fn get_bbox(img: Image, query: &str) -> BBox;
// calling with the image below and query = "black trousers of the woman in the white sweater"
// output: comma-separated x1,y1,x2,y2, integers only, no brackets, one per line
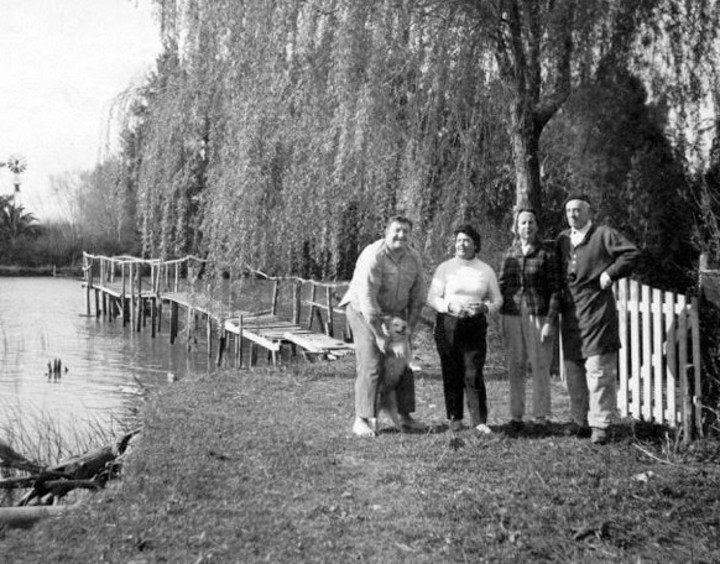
435,313,487,427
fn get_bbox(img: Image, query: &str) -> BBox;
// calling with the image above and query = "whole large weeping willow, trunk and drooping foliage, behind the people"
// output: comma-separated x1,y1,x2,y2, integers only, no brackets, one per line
135,0,717,277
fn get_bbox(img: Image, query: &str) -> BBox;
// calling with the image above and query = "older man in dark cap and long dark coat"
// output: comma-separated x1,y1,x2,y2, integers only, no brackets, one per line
557,194,639,444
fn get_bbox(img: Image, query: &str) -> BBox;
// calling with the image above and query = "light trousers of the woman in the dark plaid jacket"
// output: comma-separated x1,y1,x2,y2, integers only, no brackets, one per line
502,301,555,421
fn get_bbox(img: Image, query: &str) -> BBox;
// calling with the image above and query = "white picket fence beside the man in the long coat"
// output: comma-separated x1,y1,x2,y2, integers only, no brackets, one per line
560,278,702,438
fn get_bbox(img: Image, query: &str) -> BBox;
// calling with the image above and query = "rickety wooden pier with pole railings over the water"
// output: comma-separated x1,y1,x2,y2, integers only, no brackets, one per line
83,253,353,367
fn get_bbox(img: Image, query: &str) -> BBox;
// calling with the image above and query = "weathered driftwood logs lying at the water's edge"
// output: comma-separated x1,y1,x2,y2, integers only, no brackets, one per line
0,429,140,527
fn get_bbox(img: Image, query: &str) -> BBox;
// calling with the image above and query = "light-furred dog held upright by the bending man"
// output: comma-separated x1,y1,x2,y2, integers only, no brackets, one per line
378,316,411,430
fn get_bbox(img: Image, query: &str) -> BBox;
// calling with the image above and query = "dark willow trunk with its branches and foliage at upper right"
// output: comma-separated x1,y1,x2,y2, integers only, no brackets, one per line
444,0,720,209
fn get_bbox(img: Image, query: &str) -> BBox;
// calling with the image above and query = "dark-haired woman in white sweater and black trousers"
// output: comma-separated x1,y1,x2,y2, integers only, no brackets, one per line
428,225,502,434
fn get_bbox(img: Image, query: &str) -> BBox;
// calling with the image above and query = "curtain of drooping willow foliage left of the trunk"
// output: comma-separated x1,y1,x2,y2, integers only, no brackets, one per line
138,0,505,276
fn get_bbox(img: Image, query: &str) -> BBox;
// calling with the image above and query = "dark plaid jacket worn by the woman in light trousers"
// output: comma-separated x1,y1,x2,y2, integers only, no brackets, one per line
499,242,562,322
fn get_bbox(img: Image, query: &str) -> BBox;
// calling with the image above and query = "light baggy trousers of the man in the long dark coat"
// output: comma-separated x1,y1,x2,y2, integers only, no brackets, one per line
563,351,618,429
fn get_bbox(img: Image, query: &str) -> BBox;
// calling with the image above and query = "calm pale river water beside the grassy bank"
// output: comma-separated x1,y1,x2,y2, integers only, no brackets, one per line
0,277,213,454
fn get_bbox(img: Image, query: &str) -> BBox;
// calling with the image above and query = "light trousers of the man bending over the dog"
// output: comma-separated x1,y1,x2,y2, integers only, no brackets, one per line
345,305,415,419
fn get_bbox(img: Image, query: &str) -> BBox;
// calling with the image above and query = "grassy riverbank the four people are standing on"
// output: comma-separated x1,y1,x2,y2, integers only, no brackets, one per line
0,328,720,564
